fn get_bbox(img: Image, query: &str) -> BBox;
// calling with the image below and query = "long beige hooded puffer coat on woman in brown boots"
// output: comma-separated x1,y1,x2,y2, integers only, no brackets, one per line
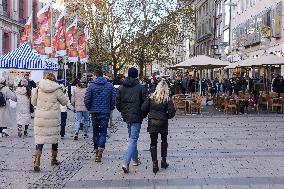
32,79,68,144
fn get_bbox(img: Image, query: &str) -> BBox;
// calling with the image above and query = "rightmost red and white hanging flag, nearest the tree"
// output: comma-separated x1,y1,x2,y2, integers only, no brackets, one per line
78,26,88,63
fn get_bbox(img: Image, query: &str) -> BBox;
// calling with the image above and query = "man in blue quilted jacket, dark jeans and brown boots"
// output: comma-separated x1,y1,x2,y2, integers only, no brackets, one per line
84,70,116,162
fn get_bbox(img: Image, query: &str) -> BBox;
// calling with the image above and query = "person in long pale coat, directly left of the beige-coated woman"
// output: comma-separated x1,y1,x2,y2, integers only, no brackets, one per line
16,80,31,137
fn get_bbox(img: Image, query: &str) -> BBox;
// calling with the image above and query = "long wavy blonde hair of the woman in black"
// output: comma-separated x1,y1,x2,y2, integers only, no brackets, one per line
150,81,169,104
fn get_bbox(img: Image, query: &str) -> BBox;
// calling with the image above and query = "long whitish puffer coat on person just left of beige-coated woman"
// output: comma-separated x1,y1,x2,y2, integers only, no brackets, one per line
16,87,31,126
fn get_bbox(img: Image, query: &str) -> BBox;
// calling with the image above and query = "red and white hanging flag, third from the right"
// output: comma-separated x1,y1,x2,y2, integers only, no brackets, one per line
52,8,67,56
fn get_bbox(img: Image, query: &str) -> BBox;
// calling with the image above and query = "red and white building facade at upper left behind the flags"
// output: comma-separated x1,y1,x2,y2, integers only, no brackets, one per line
0,0,43,55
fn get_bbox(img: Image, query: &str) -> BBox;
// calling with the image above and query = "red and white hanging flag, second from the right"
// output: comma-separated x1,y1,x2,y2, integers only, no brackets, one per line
66,15,78,62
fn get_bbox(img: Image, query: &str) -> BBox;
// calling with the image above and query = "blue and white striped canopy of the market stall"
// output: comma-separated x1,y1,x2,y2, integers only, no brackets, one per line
0,43,58,70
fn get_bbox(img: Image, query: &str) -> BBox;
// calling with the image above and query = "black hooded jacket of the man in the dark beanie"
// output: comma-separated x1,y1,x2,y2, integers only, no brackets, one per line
116,77,147,124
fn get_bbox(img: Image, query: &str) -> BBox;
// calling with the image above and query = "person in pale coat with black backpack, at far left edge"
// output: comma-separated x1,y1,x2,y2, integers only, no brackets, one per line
0,78,17,137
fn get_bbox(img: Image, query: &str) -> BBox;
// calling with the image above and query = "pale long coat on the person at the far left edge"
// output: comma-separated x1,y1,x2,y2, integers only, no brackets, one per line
0,84,17,128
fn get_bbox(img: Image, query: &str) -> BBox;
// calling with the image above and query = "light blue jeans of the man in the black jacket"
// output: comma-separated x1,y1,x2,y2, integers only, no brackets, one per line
124,123,141,165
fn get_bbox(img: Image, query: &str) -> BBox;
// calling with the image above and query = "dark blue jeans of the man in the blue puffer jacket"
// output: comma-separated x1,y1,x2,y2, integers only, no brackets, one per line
92,113,110,150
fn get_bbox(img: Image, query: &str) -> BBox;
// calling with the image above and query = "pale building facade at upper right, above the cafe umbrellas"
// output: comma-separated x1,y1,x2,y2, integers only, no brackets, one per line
231,0,284,77
